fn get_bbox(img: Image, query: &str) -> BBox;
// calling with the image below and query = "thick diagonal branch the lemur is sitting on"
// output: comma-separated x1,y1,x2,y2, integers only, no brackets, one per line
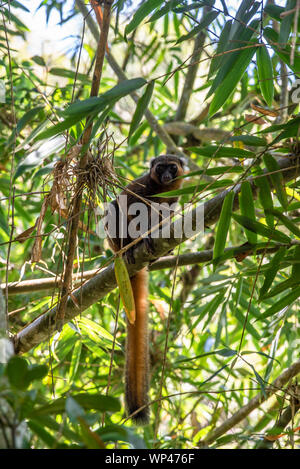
14,157,299,353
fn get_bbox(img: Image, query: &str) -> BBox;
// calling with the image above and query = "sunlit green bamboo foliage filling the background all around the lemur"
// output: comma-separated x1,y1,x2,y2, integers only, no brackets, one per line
0,0,300,449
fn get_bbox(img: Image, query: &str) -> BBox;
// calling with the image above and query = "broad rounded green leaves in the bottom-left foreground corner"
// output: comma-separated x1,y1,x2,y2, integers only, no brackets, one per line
0,357,137,449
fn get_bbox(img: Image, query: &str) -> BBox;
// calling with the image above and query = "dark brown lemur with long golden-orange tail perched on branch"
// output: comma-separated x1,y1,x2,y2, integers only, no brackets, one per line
109,155,184,425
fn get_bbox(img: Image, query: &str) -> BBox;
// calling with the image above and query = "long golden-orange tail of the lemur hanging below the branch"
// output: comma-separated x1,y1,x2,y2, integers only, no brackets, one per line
125,268,149,425
